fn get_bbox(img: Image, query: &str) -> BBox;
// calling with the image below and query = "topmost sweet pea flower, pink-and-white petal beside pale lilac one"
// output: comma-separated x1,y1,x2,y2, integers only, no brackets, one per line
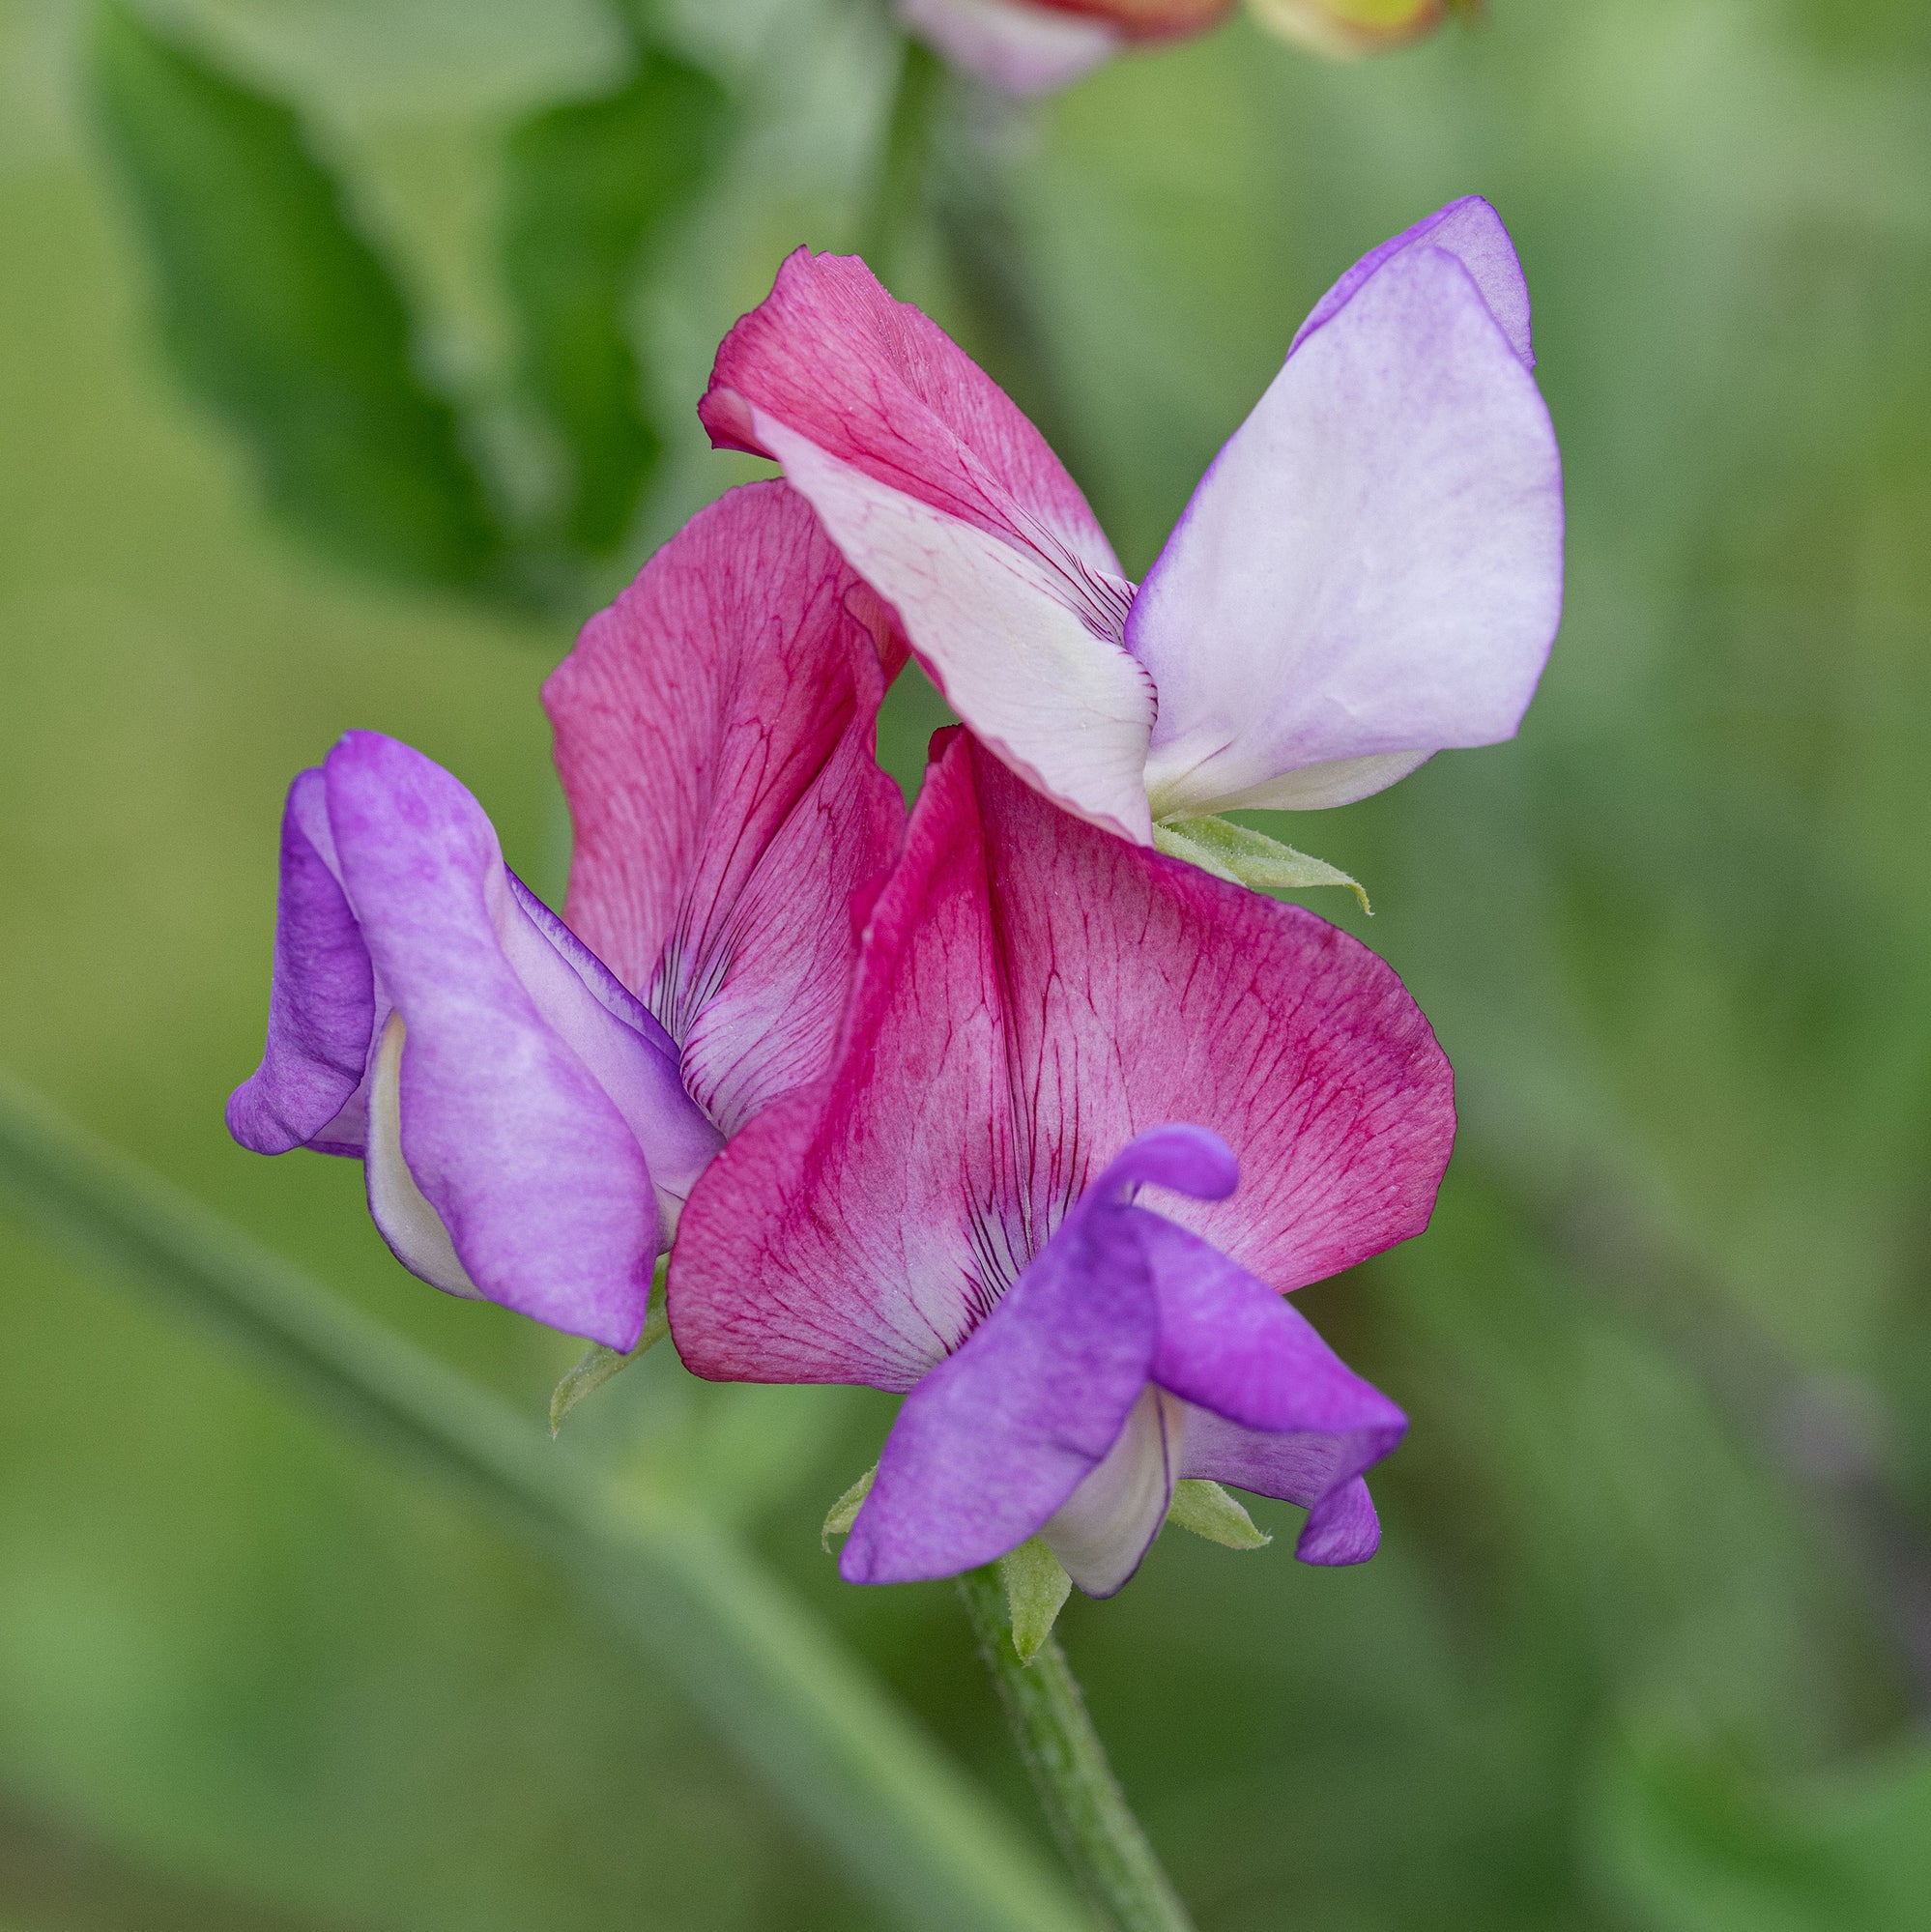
702,195,1562,845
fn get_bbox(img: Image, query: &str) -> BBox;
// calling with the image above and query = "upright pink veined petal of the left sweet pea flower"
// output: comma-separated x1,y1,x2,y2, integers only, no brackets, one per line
543,483,905,1128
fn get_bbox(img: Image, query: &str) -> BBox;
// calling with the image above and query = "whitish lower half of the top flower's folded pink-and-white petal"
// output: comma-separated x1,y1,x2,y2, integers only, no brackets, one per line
754,412,1154,845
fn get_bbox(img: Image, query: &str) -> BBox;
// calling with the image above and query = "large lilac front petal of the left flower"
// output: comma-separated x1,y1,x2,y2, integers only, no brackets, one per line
325,733,688,1348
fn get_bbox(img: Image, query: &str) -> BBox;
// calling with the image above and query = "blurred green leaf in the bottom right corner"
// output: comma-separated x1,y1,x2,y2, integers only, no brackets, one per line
1602,1743,1931,1932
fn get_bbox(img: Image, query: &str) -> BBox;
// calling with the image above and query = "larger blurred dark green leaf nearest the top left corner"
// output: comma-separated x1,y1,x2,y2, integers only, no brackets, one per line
93,6,503,586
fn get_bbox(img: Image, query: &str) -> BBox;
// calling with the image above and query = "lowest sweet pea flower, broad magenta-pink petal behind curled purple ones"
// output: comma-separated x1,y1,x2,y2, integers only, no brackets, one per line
667,729,1454,1596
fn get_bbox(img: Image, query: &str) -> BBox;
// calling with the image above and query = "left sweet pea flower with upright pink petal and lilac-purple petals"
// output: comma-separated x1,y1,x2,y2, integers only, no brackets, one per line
228,483,903,1350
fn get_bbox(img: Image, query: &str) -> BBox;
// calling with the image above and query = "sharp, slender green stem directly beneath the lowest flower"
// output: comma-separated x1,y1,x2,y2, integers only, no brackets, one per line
959,1565,1193,1932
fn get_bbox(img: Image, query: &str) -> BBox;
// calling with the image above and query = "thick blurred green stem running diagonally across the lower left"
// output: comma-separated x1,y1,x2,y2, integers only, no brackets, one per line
0,1074,1090,1932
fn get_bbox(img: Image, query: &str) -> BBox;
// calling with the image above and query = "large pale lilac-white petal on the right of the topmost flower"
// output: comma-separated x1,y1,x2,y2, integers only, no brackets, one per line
1127,240,1562,818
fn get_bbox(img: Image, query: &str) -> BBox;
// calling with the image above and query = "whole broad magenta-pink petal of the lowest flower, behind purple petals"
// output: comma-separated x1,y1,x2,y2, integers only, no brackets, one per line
671,733,1454,1389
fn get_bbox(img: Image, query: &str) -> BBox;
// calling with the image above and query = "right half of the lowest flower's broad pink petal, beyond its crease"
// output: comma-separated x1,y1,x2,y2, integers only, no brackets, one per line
974,735,1455,1290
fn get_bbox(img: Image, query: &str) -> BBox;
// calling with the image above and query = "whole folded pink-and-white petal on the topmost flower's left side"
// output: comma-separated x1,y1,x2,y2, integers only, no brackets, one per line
702,249,1154,841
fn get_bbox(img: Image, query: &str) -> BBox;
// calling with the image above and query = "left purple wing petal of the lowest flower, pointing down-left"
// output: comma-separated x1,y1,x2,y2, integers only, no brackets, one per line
839,1201,1158,1582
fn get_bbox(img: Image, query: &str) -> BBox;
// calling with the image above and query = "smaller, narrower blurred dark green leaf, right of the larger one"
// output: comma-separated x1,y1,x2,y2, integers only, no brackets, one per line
503,37,727,557
